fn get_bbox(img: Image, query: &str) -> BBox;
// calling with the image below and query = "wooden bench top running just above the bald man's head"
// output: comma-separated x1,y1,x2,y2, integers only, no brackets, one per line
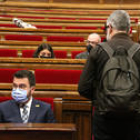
0,28,105,38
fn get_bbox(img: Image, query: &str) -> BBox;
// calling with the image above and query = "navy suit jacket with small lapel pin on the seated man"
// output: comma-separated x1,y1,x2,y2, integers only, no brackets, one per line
0,99,55,123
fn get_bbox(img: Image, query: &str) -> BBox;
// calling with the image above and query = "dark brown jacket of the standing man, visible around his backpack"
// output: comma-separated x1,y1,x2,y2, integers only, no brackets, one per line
78,33,140,100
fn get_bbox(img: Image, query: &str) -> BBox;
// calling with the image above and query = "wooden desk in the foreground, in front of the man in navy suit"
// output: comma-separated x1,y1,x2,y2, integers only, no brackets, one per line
0,123,76,140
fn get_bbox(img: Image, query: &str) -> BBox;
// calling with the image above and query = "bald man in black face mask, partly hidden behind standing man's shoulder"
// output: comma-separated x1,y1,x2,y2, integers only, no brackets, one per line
75,33,101,59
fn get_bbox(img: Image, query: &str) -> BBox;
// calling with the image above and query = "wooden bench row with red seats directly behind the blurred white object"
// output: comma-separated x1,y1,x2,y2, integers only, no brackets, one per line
0,15,139,29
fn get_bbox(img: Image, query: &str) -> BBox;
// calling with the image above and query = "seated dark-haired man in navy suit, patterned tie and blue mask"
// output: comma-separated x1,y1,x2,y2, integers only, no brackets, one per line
0,70,55,123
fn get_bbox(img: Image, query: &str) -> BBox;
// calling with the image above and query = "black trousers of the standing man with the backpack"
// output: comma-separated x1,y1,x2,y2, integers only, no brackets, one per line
92,111,140,140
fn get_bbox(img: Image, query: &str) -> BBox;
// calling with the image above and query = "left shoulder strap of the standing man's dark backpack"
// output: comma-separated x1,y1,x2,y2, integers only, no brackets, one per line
98,42,114,57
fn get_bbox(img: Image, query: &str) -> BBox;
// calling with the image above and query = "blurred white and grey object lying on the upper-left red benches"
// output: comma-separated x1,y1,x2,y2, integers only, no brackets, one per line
13,18,37,29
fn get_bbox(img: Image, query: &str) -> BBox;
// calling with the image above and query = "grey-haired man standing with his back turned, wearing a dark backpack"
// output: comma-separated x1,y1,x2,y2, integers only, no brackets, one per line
78,10,140,140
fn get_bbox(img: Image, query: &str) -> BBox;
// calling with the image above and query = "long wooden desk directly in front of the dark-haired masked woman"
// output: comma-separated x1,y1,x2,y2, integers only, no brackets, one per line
0,57,86,70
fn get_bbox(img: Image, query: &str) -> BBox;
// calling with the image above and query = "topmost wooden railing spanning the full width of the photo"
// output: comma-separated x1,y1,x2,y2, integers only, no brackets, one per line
0,0,140,10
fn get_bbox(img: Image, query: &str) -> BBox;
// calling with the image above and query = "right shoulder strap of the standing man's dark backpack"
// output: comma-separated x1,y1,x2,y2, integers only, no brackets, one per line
128,43,140,58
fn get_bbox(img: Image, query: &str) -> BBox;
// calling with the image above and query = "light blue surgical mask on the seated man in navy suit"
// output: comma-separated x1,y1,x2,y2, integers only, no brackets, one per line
12,88,28,103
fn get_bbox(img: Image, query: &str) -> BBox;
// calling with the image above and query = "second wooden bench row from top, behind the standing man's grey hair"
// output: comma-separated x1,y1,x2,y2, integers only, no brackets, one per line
0,8,140,19
